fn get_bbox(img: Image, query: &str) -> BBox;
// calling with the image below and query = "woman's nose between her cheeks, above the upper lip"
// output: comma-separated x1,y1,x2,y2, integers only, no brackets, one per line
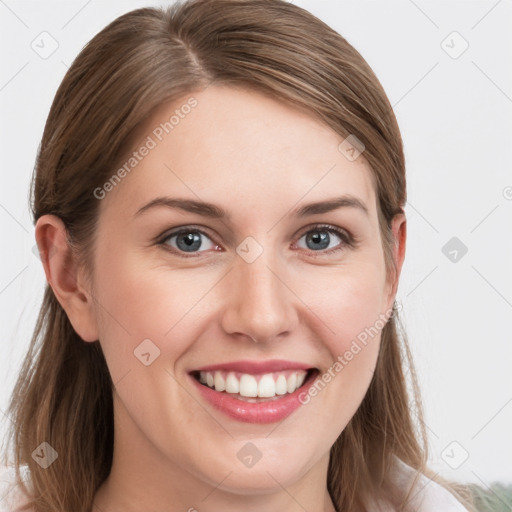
222,251,298,344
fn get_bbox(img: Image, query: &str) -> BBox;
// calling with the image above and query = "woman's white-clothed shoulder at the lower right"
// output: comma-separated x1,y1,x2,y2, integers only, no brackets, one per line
394,459,468,512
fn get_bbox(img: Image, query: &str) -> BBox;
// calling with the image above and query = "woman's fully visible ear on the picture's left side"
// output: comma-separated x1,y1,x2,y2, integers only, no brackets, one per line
35,215,98,341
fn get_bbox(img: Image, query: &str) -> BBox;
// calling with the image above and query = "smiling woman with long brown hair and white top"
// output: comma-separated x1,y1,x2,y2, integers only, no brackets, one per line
0,0,470,512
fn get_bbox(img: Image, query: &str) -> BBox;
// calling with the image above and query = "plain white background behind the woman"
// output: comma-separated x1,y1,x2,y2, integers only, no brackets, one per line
0,0,512,492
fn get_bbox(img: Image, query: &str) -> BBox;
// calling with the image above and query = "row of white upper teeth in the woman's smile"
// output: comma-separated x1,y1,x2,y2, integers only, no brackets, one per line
199,370,307,398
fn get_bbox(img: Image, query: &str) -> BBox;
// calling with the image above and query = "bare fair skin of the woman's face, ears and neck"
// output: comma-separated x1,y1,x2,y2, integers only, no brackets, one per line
36,85,406,512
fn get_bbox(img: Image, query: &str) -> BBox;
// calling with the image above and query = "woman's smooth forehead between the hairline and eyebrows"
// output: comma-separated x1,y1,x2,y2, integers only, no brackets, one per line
102,85,375,218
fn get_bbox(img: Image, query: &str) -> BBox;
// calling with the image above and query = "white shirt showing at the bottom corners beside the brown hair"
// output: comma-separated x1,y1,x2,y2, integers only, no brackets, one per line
0,461,468,512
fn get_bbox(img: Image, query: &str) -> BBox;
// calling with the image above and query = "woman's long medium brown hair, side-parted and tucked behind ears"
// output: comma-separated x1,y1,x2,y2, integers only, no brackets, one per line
4,0,474,512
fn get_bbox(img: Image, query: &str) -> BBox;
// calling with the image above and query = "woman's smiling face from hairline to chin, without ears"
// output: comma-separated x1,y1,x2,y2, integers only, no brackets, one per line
84,86,400,493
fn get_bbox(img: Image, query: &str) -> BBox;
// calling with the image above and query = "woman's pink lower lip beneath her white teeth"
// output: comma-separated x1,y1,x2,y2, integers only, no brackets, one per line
190,371,317,423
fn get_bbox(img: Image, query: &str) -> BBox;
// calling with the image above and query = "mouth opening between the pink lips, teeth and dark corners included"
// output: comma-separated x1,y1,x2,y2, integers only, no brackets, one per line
190,368,318,403
